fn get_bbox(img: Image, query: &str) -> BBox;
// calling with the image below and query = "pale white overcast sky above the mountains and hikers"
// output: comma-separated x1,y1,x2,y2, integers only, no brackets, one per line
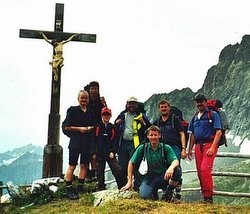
0,0,250,152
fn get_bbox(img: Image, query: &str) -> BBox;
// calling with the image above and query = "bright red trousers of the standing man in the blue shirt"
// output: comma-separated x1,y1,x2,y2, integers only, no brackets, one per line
195,143,218,198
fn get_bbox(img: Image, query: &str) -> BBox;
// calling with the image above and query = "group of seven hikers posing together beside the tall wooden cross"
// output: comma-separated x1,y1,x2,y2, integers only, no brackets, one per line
62,81,226,203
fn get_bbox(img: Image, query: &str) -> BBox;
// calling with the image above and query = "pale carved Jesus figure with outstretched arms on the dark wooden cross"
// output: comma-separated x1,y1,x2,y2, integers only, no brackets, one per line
41,32,75,81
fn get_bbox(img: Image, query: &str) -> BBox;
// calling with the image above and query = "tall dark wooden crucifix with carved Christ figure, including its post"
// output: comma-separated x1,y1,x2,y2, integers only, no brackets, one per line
19,3,96,178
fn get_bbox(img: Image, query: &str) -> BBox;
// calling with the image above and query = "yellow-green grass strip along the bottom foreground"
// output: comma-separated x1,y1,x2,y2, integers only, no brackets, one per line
0,195,250,214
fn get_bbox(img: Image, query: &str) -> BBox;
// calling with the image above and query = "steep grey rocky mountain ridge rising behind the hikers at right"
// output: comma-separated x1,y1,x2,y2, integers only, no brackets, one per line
144,35,250,152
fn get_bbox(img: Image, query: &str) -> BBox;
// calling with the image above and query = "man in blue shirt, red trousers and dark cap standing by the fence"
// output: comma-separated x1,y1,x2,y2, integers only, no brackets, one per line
188,93,221,204
